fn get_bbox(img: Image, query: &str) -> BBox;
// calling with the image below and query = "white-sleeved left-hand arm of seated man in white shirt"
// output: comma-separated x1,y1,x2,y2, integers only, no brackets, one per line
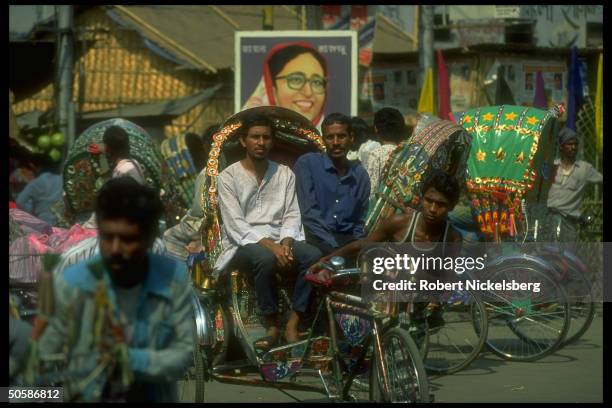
217,173,266,246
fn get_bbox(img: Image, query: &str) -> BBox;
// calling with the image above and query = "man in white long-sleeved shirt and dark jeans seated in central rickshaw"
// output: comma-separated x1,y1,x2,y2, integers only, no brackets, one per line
215,115,322,349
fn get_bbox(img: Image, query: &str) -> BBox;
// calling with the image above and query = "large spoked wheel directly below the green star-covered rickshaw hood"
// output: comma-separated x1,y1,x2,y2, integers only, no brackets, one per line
483,263,570,361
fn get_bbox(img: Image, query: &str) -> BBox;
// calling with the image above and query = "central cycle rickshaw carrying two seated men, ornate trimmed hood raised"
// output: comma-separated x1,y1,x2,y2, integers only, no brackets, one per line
186,107,430,402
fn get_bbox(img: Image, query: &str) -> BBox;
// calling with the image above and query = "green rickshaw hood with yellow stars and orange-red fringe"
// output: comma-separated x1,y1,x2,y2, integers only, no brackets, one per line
456,105,559,239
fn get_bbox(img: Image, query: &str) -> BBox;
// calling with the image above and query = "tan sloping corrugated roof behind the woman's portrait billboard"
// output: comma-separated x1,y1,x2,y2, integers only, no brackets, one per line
27,5,416,73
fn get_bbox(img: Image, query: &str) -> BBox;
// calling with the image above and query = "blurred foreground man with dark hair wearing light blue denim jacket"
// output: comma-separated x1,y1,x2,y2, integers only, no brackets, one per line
39,177,195,402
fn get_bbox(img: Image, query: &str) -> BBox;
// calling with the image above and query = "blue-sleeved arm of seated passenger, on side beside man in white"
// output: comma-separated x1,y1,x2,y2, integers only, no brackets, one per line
293,159,338,247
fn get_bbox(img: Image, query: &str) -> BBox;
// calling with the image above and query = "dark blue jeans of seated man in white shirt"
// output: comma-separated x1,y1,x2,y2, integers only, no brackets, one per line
232,241,323,316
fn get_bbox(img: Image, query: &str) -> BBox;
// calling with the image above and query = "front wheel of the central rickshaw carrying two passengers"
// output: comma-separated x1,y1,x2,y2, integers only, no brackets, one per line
370,327,429,402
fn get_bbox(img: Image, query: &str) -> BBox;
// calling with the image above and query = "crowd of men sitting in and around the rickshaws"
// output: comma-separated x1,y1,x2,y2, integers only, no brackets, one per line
10,102,602,401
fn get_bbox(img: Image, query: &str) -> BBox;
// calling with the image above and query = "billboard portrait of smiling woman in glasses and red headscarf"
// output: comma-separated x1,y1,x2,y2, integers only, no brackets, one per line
234,31,358,128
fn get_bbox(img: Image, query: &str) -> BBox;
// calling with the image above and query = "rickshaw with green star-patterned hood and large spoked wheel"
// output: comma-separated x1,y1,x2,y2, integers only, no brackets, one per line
455,105,570,361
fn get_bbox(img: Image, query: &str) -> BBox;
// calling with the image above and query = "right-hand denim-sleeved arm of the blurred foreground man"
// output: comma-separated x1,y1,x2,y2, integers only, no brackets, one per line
128,263,195,381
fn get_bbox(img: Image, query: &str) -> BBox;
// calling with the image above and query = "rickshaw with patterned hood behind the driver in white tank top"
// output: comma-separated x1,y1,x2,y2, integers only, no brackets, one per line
366,115,487,375
